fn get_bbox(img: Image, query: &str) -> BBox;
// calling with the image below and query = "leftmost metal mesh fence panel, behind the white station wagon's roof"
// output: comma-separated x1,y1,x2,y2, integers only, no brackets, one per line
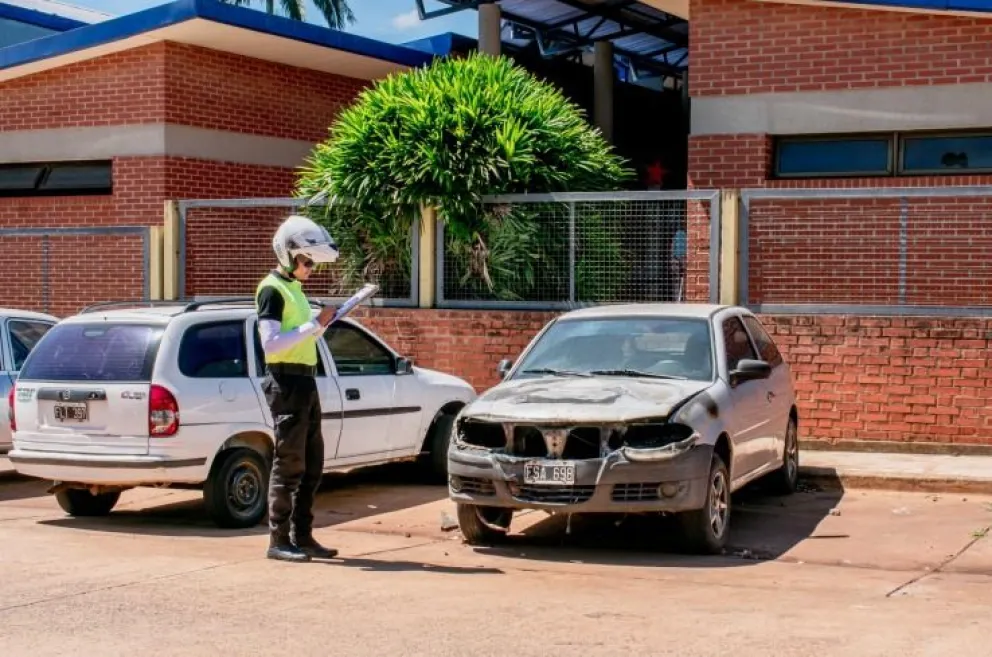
0,226,151,316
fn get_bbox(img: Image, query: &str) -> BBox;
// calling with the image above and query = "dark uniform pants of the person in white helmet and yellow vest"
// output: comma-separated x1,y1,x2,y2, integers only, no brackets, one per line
262,372,324,542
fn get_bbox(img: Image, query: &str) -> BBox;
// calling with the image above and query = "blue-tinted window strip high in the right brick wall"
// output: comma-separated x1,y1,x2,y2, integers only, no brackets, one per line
772,132,992,178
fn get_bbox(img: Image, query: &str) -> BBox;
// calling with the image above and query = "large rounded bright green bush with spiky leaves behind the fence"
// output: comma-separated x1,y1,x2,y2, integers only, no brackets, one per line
297,54,631,299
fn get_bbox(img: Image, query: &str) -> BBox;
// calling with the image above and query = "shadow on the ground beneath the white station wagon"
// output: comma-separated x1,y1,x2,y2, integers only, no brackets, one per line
35,463,448,538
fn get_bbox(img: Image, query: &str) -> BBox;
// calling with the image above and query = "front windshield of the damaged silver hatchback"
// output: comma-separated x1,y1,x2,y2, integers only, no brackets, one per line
514,317,713,381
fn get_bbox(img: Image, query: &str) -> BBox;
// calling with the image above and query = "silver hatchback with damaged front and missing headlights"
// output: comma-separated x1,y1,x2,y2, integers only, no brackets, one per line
448,304,799,553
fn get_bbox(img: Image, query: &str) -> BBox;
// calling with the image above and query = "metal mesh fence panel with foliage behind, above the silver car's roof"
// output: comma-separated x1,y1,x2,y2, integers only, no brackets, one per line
436,190,720,309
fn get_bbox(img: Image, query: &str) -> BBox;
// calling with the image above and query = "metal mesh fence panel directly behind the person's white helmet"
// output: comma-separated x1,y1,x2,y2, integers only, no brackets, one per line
177,198,420,306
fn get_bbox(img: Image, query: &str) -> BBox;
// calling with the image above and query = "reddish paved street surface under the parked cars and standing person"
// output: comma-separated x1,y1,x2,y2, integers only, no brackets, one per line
0,467,992,657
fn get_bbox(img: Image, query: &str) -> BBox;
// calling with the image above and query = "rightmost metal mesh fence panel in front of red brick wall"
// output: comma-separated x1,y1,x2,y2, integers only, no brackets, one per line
738,186,992,315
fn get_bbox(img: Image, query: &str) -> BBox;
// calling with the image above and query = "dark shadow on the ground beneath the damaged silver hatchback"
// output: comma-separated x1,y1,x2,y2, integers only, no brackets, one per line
476,477,846,568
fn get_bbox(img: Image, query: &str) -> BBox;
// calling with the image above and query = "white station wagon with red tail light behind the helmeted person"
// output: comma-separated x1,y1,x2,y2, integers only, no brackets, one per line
10,300,475,527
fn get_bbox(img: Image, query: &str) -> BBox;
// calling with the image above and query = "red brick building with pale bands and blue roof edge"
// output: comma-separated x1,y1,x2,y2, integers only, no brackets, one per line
0,0,992,445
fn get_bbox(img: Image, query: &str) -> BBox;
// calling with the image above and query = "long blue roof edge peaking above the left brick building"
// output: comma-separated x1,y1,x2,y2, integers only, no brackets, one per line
0,0,433,69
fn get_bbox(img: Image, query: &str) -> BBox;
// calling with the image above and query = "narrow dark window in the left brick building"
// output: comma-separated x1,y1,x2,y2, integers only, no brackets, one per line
0,161,113,196
